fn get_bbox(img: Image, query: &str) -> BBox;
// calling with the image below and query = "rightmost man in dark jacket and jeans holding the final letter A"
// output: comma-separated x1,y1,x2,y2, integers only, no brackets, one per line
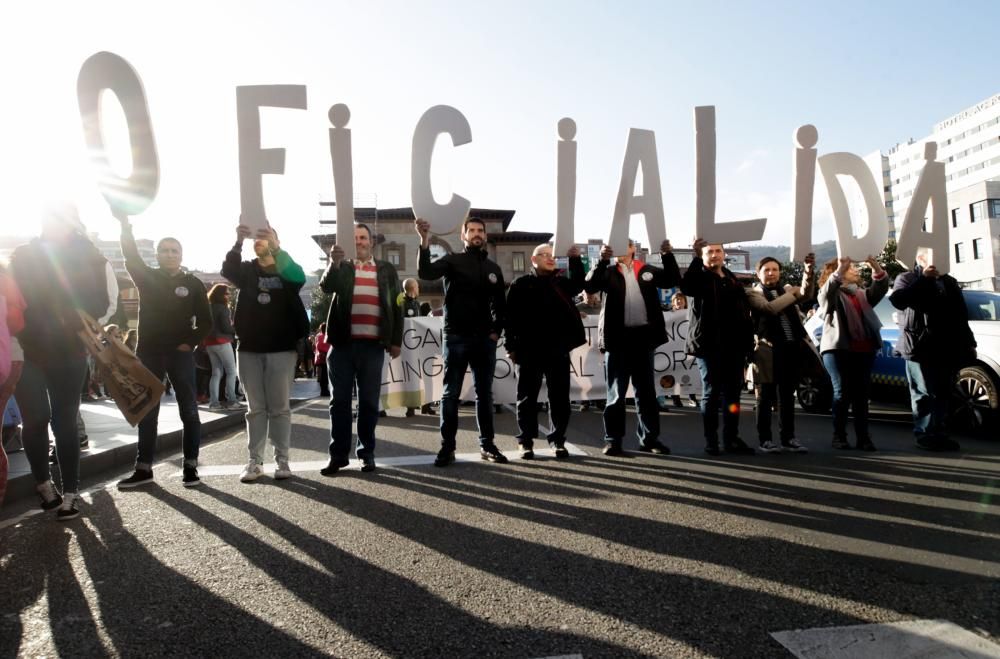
889,249,976,451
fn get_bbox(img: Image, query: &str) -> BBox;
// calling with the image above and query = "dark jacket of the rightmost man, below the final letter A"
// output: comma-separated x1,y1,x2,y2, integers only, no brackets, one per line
889,266,976,365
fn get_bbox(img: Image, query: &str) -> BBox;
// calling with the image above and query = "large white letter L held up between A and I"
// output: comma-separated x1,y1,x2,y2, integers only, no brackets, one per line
694,105,767,244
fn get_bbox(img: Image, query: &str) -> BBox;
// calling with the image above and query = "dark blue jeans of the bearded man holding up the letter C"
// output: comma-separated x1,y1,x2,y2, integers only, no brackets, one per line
441,335,497,451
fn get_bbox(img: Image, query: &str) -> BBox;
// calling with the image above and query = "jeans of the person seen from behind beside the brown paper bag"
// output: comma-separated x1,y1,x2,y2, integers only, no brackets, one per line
14,355,87,492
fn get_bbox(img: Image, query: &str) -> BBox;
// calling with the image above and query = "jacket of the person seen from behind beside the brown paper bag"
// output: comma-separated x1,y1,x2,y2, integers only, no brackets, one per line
10,235,110,364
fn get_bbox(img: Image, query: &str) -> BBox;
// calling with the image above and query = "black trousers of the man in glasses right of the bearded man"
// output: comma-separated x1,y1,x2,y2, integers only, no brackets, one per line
517,352,570,448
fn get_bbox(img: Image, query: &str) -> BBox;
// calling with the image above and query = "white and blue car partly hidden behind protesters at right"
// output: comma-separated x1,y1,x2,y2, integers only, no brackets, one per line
797,290,1000,431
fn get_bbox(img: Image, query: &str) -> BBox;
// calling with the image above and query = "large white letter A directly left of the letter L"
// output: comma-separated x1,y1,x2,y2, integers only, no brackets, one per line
608,128,667,254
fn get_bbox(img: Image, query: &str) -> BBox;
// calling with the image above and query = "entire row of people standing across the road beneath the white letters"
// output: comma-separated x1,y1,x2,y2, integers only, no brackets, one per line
0,207,975,520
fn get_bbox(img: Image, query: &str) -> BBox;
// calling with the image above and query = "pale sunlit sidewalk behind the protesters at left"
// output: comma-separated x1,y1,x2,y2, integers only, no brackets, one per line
4,379,319,505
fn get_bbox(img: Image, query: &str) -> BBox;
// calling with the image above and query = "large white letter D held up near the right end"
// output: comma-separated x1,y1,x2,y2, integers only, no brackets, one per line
819,152,889,260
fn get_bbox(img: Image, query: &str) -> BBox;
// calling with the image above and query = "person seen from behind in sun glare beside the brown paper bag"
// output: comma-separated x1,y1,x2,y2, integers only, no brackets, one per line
10,206,118,520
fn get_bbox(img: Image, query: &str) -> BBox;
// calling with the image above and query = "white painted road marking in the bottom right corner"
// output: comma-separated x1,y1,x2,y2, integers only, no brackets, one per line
771,620,1000,659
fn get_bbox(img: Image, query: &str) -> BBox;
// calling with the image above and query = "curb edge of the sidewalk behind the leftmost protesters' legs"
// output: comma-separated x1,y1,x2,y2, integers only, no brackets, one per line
4,398,313,508
